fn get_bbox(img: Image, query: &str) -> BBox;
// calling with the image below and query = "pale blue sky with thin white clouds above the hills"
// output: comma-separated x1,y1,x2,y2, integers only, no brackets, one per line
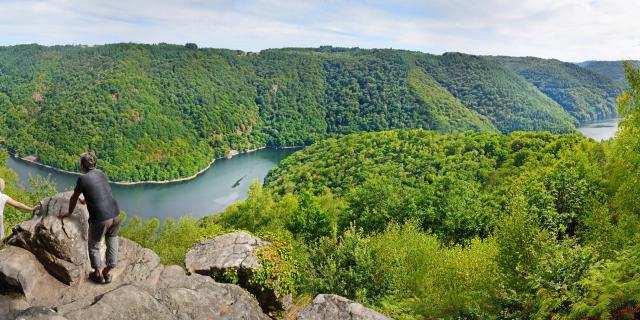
0,0,640,62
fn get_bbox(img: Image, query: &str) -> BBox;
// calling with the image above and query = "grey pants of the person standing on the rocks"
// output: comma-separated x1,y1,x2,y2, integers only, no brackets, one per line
89,216,120,269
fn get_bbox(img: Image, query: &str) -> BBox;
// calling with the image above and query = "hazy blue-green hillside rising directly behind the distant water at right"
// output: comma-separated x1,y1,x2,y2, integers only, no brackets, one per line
493,57,622,122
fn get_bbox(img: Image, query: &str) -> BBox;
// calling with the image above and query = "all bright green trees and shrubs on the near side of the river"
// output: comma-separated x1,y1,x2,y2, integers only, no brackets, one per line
0,65,640,319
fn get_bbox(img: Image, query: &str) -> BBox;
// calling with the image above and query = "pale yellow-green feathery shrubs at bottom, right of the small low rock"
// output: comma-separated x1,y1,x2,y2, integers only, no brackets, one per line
372,223,497,319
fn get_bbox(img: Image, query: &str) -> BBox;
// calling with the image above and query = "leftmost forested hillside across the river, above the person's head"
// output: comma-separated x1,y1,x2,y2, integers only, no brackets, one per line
0,44,264,181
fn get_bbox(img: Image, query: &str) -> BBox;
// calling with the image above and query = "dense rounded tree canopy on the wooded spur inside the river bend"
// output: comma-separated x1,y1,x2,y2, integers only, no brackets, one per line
265,130,604,243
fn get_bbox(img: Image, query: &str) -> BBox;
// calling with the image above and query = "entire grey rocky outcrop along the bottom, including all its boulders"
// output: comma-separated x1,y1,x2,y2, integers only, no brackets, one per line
0,193,396,320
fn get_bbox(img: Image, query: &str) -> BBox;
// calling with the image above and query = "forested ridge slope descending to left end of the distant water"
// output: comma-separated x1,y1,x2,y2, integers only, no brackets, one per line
415,53,576,133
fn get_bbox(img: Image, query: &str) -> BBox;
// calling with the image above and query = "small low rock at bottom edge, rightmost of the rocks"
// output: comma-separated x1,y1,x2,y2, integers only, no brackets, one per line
298,294,391,320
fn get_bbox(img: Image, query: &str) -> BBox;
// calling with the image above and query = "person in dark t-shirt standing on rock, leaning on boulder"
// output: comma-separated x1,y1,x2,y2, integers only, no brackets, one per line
60,152,120,284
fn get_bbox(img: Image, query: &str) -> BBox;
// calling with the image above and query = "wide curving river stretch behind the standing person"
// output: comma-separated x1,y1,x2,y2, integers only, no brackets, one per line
8,149,297,220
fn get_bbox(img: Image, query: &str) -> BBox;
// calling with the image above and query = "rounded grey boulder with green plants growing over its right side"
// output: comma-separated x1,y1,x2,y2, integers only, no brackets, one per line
185,232,292,315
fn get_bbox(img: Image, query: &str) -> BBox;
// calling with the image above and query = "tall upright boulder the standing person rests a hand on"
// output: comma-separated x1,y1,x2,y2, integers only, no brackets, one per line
8,192,90,285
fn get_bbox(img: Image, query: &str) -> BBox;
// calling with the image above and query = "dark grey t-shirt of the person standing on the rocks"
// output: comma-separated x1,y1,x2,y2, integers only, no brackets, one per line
75,169,120,223
